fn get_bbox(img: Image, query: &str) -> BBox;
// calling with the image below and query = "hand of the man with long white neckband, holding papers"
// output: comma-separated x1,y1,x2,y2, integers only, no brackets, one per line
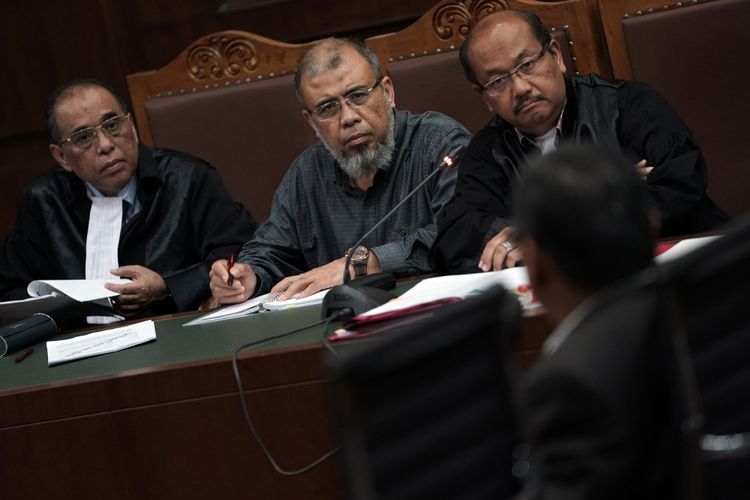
104,266,169,314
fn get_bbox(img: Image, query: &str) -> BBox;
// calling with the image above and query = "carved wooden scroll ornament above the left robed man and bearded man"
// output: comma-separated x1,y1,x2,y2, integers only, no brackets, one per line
186,36,258,81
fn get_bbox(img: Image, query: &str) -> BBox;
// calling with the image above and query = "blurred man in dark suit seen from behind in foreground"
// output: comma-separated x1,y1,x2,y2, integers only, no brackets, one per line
513,147,680,500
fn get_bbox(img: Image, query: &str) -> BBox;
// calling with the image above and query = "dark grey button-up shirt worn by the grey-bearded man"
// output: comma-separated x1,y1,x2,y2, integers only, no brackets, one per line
238,111,470,293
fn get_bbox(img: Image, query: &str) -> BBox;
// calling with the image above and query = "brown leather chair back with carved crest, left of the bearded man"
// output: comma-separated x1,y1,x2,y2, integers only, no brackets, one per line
128,31,315,221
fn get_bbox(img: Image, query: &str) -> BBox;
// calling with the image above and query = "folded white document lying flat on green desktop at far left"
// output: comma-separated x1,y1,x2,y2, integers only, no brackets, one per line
47,320,156,366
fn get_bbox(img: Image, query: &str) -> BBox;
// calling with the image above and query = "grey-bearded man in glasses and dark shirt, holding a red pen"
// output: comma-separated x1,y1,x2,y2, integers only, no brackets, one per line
210,38,470,304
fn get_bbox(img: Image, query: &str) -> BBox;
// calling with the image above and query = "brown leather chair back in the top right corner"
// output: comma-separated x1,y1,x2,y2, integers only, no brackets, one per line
600,0,750,217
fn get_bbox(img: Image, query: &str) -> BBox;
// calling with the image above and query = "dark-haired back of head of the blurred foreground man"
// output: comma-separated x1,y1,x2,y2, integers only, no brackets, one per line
514,146,653,290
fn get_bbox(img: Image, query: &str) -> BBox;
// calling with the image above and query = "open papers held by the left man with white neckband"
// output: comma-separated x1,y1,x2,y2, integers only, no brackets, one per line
0,278,130,320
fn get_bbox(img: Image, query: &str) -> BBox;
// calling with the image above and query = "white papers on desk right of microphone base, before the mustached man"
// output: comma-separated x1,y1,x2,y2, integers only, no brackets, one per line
355,267,541,319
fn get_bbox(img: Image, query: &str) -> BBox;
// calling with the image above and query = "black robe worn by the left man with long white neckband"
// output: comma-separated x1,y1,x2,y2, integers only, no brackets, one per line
0,146,257,316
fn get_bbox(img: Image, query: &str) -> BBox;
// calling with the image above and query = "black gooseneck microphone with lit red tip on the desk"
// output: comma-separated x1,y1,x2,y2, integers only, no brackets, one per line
321,146,464,318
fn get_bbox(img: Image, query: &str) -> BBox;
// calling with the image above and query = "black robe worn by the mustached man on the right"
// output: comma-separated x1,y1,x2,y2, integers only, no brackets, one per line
431,75,728,273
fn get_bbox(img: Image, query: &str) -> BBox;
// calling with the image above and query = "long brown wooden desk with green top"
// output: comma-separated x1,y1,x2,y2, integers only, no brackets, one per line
0,294,549,500
